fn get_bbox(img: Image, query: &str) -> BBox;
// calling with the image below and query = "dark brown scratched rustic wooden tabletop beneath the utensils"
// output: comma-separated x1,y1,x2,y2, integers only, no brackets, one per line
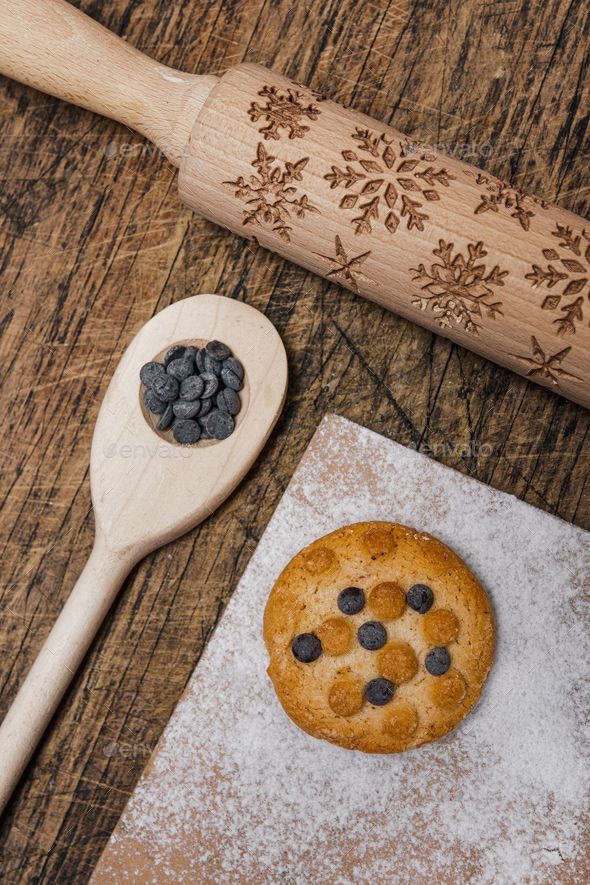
0,0,590,883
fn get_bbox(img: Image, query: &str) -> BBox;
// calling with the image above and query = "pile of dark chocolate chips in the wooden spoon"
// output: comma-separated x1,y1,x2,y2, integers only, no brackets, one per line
139,341,244,445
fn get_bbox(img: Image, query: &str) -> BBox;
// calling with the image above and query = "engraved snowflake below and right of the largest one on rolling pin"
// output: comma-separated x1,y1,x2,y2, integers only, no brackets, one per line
410,240,508,335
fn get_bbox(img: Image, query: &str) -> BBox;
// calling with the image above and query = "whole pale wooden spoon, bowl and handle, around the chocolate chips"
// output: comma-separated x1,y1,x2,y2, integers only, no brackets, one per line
0,295,287,811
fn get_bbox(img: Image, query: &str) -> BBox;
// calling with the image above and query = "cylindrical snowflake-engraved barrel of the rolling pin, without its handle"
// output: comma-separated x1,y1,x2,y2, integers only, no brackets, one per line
178,63,590,408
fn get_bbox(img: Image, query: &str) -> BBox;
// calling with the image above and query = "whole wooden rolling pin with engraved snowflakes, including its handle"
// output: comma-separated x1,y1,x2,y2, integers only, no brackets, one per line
0,0,590,407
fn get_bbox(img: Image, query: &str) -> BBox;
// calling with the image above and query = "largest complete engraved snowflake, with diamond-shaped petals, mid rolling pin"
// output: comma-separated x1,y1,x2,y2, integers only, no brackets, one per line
324,127,455,234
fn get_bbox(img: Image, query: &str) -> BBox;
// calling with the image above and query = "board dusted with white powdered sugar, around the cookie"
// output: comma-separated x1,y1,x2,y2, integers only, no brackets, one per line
95,417,590,883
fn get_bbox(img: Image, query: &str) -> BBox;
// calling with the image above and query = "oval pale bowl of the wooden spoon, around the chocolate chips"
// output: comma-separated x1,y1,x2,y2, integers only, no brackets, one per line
90,295,287,559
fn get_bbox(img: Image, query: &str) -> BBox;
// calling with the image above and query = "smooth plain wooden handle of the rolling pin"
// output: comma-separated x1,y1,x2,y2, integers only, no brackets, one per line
0,0,217,165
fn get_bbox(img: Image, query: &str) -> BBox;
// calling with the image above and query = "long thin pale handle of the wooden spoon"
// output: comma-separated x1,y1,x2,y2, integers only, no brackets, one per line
0,542,133,812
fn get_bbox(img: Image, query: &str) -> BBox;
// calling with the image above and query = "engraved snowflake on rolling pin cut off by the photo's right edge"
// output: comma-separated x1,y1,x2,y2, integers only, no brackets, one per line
526,224,590,335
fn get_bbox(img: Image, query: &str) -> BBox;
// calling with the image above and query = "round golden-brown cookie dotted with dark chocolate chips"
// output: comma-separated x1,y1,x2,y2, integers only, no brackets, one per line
264,522,495,753
